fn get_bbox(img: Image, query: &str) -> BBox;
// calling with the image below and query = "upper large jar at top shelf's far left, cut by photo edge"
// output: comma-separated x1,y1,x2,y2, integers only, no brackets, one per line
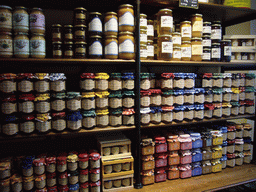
0,5,13,32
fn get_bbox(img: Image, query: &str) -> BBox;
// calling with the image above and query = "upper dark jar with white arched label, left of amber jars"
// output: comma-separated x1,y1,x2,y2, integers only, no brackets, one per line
88,12,102,36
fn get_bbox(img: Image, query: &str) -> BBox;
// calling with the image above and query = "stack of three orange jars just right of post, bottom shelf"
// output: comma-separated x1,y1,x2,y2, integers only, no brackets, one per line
141,138,155,185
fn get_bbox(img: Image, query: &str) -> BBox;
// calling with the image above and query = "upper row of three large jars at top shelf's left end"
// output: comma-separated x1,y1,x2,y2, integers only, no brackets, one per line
0,5,45,34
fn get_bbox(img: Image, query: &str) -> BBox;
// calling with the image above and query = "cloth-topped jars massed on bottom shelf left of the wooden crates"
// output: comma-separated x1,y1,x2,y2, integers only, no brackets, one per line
0,150,101,192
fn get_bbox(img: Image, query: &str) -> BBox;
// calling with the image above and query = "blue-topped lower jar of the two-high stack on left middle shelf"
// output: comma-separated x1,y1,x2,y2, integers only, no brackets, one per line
67,111,83,131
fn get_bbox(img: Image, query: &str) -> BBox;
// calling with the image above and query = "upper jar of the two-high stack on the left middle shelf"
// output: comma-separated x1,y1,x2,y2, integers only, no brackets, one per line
66,92,82,112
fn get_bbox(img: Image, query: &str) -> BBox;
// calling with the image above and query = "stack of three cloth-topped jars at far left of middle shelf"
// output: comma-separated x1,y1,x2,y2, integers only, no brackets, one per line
0,73,19,136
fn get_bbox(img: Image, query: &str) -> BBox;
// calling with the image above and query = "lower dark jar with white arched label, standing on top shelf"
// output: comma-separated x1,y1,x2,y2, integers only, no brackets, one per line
88,35,103,59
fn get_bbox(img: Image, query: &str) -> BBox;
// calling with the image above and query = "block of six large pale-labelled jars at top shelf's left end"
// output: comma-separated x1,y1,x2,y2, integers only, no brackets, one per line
0,5,45,59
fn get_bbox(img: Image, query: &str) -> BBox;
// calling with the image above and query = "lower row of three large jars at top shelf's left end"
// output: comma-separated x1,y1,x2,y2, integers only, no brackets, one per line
0,32,46,59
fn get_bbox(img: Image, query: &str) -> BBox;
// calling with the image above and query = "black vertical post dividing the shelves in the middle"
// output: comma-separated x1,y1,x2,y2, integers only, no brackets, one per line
134,0,143,189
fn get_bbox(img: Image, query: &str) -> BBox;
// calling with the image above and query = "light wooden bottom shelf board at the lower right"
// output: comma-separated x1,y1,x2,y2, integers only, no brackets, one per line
129,164,256,192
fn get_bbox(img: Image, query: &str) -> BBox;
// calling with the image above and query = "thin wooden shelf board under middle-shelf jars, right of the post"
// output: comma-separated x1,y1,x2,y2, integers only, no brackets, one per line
141,115,254,128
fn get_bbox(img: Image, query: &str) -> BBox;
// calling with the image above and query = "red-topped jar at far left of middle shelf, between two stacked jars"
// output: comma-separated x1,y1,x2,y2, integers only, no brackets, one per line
1,95,18,115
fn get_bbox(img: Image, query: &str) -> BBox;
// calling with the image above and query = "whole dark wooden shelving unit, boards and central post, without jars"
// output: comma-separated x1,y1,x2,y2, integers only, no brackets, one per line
0,0,256,191
